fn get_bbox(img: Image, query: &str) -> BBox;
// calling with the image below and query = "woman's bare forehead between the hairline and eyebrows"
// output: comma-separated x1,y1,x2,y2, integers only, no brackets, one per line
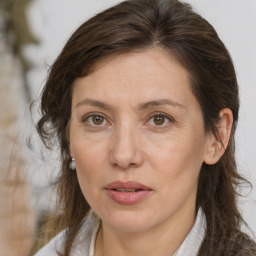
73,48,195,107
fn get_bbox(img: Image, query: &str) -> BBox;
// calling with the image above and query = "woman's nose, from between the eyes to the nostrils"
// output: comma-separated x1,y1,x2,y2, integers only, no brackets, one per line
110,124,144,170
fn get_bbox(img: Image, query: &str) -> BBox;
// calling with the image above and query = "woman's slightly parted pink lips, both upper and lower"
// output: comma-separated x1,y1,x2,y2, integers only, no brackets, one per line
105,181,153,205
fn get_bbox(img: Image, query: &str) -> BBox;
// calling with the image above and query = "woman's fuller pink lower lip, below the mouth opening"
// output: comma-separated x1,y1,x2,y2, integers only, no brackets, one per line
107,189,152,205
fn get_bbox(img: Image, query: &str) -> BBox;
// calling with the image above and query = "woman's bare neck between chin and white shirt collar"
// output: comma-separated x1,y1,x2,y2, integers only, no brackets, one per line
96,206,195,256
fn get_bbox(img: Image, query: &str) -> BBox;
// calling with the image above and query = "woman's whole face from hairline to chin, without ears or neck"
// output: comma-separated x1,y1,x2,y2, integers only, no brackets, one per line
70,48,213,232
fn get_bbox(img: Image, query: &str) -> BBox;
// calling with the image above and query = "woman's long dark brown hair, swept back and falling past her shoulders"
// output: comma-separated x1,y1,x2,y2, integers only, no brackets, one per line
37,0,256,255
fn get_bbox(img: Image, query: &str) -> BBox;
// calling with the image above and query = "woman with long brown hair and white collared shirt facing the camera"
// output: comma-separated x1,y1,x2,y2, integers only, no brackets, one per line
34,0,256,256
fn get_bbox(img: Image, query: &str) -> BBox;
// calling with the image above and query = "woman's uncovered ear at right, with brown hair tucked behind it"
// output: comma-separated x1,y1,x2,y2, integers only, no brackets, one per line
204,108,233,165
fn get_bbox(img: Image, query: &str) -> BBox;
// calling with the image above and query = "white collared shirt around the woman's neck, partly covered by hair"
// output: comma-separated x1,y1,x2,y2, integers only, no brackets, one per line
35,209,206,256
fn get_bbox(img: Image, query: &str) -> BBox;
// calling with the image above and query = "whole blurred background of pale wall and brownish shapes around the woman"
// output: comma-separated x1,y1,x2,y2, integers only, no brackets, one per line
0,0,256,256
